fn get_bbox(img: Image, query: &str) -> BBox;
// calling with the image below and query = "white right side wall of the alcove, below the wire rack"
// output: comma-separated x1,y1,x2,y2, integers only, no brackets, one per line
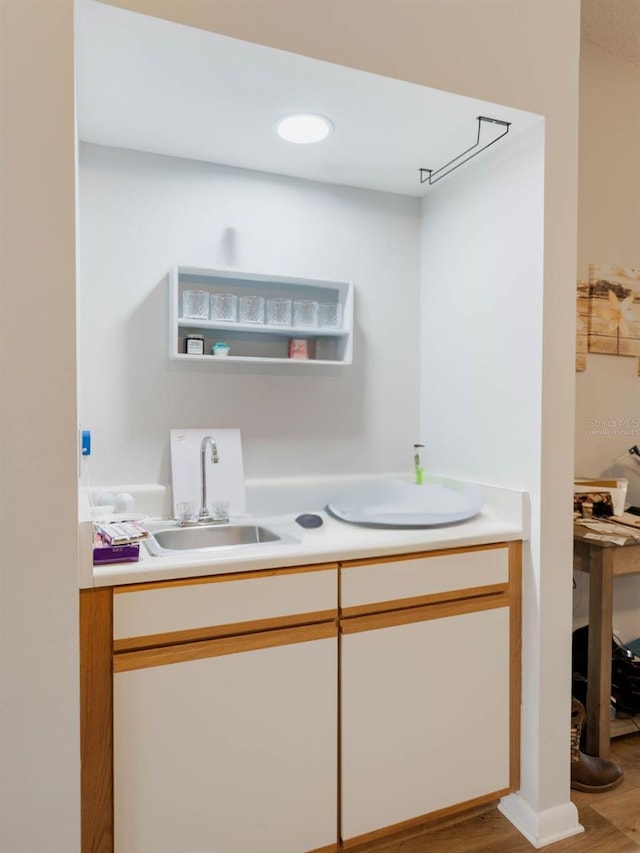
421,120,544,493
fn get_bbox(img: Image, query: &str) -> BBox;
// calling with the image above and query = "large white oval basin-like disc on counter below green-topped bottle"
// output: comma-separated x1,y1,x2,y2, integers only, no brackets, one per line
327,477,484,528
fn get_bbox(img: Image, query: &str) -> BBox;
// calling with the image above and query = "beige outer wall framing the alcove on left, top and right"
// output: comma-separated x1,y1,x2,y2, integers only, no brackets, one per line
0,0,579,853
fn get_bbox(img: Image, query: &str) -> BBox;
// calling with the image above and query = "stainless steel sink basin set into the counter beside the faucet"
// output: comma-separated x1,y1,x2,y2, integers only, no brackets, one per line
144,524,287,557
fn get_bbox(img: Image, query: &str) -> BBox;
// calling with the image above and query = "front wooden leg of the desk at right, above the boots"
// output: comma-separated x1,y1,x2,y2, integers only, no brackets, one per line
585,548,613,758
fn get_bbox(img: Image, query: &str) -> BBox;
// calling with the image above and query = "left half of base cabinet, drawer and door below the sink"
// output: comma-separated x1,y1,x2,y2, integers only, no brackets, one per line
112,564,338,853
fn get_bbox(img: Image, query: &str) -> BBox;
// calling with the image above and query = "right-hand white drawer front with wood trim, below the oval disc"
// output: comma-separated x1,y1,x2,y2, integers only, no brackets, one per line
340,544,509,615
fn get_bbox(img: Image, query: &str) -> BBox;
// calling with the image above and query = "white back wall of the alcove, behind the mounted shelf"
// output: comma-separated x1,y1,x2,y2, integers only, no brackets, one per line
80,145,419,485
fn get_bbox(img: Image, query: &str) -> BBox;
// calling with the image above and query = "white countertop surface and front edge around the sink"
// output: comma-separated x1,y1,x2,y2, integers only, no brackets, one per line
93,508,523,586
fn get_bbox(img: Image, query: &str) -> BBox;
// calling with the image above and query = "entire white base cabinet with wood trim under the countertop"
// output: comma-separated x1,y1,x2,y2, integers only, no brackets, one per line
81,542,521,853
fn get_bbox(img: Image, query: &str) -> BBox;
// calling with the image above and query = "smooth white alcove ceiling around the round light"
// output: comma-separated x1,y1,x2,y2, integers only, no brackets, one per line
76,0,541,196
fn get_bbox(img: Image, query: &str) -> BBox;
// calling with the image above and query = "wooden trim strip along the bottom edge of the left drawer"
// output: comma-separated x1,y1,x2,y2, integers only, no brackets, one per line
113,610,338,654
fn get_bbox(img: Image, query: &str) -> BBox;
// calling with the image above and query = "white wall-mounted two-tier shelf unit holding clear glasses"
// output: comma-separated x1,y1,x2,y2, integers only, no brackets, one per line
169,266,353,365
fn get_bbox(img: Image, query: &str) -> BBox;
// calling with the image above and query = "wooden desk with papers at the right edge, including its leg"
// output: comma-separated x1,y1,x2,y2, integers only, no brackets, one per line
573,525,640,758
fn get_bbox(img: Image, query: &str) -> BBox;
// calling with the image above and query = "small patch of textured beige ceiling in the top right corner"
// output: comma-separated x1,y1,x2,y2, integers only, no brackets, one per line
581,0,640,65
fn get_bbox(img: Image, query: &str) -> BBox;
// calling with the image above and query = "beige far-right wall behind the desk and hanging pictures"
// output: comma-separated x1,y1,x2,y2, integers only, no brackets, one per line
574,42,640,640
